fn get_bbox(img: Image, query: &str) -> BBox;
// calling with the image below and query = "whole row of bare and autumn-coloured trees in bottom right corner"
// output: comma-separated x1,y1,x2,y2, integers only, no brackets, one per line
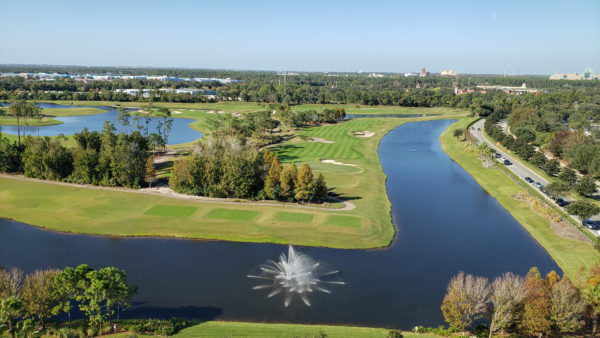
441,265,600,337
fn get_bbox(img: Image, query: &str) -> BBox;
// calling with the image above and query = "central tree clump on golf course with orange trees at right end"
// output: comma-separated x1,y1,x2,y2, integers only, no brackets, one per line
169,135,327,203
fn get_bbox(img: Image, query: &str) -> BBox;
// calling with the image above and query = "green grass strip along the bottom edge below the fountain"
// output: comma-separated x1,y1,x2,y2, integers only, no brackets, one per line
174,321,436,338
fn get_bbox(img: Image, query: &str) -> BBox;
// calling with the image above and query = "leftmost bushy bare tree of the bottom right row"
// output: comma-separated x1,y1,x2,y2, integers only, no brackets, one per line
442,271,490,331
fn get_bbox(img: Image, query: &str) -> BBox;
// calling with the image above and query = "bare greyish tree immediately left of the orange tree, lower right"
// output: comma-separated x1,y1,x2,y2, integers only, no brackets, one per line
489,272,527,337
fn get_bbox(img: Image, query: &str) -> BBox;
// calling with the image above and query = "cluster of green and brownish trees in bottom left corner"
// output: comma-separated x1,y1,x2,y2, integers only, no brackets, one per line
0,264,137,337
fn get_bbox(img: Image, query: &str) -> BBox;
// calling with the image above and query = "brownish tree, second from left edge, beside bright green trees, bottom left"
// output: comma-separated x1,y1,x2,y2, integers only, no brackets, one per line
21,269,58,326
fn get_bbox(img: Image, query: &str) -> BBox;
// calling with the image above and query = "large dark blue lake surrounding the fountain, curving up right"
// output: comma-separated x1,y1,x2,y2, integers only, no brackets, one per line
0,120,560,329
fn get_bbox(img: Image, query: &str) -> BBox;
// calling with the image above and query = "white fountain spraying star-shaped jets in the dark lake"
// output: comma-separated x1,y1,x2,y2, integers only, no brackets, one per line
248,245,345,307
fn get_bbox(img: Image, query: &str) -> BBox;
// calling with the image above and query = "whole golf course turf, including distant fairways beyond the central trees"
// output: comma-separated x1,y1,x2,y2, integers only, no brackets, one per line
0,103,466,249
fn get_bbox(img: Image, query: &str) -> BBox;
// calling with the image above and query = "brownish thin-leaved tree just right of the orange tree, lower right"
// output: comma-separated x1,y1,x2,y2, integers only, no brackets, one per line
550,277,586,333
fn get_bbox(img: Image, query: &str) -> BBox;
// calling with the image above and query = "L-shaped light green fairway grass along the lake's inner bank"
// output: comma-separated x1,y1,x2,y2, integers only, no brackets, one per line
0,108,468,249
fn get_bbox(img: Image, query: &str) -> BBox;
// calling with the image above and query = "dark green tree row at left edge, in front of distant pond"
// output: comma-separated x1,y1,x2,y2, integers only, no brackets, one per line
0,121,150,187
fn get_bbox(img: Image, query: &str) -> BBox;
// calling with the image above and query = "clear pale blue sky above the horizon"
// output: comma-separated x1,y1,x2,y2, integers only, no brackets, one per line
0,0,600,74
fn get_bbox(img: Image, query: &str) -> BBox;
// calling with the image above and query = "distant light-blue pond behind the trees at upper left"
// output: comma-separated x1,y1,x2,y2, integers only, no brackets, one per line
2,103,203,144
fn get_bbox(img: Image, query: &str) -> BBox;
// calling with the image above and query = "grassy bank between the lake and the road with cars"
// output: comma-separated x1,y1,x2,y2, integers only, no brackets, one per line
440,120,600,279
